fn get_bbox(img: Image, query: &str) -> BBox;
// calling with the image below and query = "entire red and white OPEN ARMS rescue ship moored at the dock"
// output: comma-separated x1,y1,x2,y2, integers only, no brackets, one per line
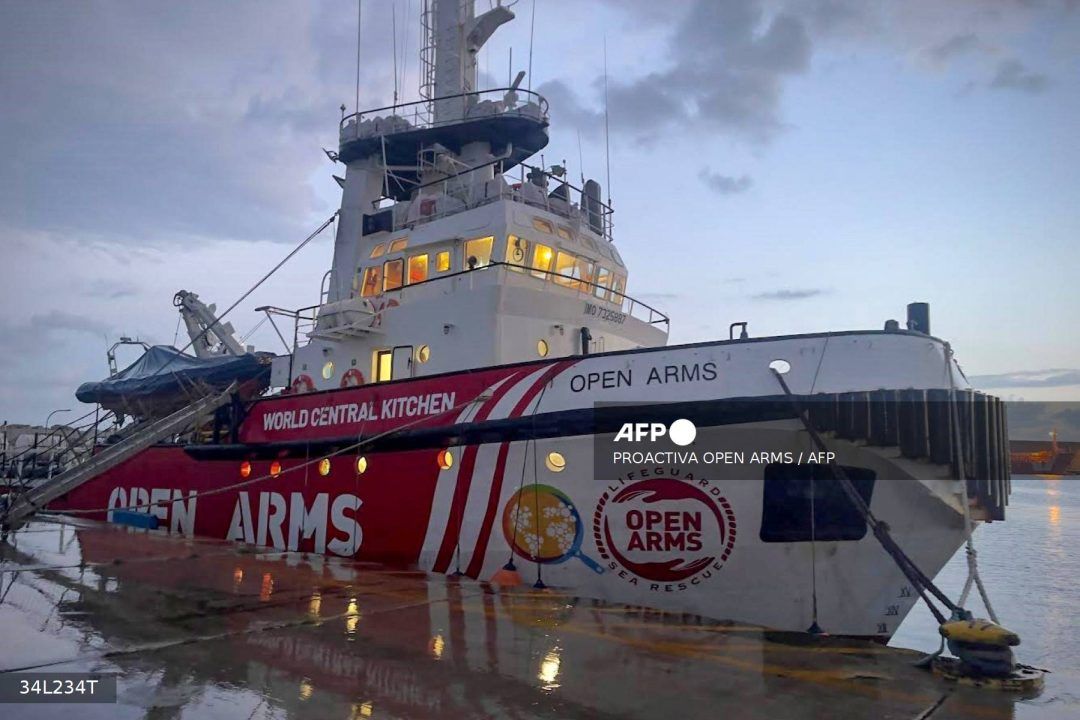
5,0,1009,640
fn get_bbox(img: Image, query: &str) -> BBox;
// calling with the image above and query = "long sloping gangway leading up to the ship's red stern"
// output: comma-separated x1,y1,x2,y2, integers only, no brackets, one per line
0,382,237,530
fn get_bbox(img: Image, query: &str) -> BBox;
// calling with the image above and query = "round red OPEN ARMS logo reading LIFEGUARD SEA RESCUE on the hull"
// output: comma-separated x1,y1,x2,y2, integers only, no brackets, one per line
593,477,735,592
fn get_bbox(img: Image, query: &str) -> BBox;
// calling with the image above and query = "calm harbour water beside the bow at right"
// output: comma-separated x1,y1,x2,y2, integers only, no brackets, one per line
891,475,1080,718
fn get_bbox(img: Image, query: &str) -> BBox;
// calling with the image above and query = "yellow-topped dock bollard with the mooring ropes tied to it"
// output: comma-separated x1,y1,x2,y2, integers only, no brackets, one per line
772,368,1042,690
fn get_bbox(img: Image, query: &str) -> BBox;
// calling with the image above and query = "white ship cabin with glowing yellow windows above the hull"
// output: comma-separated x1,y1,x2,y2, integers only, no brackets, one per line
272,168,669,392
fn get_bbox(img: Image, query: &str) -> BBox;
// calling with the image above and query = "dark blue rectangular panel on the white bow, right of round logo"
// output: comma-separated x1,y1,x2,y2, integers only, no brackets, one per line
760,463,877,543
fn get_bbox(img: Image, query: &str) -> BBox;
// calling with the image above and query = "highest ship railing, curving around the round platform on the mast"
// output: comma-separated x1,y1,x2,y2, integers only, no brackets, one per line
340,87,548,141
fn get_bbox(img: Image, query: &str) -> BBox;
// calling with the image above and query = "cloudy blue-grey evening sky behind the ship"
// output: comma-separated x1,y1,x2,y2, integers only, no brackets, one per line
0,0,1080,422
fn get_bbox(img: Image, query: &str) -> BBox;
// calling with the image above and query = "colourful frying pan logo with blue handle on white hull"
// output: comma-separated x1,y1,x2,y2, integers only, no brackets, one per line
502,485,604,574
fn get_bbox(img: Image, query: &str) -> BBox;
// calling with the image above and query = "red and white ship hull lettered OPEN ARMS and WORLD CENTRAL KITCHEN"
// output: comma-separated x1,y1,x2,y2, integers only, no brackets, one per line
52,334,980,639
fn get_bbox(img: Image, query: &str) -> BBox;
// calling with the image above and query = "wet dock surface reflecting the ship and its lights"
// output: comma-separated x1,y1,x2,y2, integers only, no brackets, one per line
0,520,1053,720
